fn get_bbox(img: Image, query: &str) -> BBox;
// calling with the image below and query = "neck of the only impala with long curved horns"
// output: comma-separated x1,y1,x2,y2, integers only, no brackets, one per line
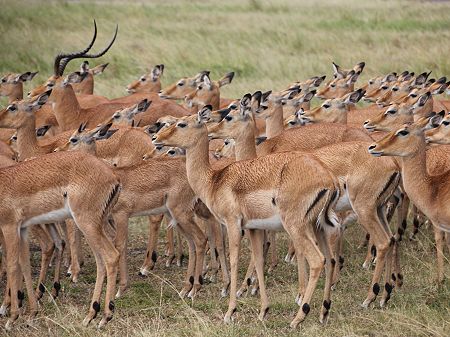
52,84,81,131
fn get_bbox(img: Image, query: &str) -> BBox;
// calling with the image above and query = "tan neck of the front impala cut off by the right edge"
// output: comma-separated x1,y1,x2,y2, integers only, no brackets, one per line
400,136,432,210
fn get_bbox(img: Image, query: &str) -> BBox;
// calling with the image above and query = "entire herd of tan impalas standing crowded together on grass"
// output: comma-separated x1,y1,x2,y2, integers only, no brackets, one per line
0,21,450,329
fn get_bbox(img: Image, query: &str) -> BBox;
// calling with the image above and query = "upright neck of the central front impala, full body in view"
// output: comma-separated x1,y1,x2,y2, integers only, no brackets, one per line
186,125,213,203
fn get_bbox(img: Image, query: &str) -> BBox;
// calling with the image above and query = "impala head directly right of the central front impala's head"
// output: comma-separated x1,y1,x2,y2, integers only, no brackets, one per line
208,91,262,139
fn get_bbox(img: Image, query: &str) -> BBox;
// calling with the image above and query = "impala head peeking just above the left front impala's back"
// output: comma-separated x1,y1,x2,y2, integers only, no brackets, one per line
53,123,117,154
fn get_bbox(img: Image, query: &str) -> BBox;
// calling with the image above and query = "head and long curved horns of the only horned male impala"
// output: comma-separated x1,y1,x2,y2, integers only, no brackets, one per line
28,20,119,97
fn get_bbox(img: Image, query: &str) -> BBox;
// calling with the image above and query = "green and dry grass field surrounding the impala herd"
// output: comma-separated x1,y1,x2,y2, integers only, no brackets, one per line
0,0,450,337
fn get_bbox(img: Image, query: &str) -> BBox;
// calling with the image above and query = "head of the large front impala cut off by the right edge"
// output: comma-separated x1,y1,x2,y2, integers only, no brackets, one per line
369,112,439,157
